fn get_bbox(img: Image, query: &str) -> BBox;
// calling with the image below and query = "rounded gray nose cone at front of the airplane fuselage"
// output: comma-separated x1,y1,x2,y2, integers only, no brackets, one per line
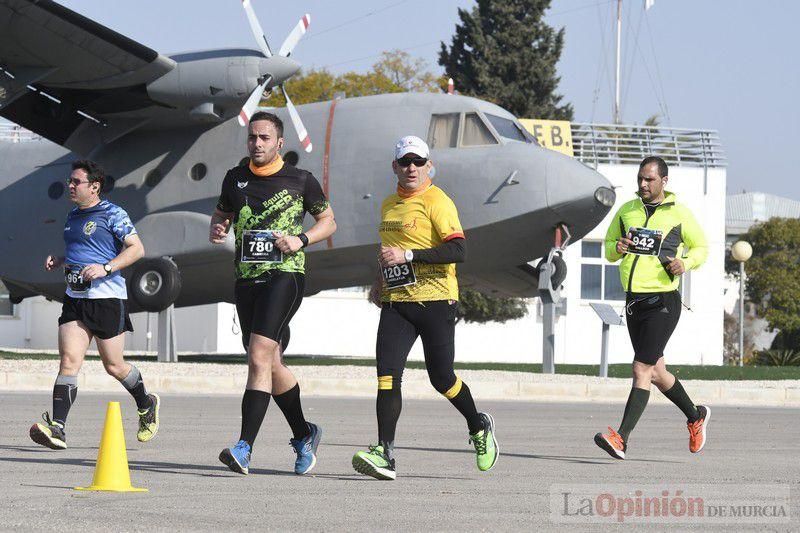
546,152,616,237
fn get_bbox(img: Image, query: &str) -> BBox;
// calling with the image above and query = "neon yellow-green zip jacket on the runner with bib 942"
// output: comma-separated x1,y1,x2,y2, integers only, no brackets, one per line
605,191,708,293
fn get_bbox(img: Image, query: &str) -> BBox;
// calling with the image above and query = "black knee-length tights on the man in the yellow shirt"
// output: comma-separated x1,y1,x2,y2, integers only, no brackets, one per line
376,300,458,394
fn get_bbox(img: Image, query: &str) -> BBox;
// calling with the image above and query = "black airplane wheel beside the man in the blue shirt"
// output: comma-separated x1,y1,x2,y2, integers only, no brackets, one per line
130,257,181,313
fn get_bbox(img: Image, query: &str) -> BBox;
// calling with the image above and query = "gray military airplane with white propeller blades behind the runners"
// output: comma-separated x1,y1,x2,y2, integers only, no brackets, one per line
0,0,614,311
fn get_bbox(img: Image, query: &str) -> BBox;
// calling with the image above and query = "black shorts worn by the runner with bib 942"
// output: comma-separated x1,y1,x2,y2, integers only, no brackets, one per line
625,291,681,365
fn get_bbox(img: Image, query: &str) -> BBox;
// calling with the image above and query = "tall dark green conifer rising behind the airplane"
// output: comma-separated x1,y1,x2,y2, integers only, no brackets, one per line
439,0,572,120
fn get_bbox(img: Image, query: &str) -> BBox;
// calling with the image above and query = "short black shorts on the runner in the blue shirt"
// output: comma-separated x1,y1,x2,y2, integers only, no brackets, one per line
58,294,133,339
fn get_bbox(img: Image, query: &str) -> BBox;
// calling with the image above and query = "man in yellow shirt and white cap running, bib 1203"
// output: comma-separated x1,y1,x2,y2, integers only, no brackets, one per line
353,136,499,479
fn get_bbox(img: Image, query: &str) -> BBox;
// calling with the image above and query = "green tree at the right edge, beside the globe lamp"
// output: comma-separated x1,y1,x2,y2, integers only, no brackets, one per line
729,218,800,349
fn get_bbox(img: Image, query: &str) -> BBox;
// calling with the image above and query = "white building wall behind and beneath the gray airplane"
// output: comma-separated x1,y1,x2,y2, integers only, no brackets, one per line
0,166,725,364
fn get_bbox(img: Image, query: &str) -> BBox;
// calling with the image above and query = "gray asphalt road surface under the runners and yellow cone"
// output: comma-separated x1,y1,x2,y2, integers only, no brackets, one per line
0,393,800,531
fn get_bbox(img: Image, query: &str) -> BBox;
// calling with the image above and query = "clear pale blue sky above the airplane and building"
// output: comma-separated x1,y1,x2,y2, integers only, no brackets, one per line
61,0,800,200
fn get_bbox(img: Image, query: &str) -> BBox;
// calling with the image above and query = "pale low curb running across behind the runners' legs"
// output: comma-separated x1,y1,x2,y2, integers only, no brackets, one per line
0,371,800,407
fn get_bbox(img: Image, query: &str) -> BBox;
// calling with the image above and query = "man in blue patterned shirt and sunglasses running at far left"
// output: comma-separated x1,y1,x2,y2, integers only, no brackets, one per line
30,161,161,450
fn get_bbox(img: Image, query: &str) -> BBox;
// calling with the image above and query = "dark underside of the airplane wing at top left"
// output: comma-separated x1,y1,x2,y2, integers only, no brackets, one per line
0,0,175,154
